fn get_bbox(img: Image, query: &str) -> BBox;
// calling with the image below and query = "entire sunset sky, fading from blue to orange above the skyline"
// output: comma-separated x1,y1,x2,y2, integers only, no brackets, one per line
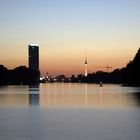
0,0,140,76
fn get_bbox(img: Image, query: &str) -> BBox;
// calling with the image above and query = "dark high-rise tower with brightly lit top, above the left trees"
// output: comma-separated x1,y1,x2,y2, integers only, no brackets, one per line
28,44,39,71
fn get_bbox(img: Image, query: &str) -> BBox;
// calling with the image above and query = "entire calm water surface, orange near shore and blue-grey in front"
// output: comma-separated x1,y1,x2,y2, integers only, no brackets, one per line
0,83,140,140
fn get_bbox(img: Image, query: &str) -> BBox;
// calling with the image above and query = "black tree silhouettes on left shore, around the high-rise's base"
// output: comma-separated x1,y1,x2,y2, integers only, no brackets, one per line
0,65,40,85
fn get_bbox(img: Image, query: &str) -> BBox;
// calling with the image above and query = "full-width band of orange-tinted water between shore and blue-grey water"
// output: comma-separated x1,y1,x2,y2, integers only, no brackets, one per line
0,83,140,108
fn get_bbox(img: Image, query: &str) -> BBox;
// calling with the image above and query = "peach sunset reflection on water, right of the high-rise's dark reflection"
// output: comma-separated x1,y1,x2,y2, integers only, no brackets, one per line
40,83,138,108
